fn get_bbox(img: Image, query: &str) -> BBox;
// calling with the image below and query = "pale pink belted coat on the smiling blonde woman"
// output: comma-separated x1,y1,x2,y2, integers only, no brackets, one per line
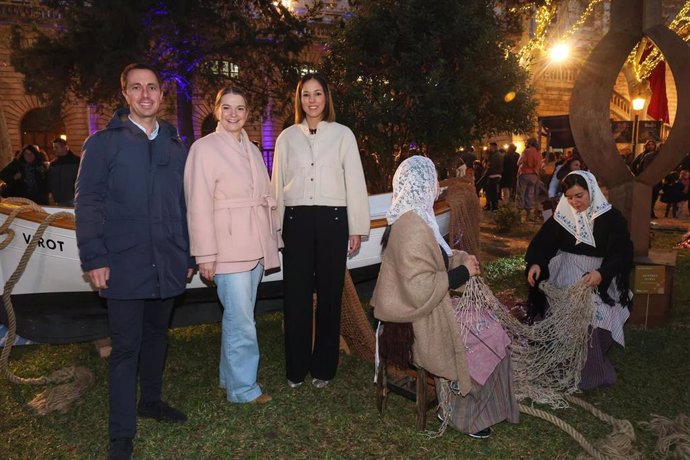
184,125,282,274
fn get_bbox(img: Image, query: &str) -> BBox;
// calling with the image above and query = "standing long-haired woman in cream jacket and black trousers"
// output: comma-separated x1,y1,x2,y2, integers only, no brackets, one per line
271,74,370,388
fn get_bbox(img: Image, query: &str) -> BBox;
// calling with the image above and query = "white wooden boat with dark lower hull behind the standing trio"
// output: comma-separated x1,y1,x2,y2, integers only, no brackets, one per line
0,193,450,343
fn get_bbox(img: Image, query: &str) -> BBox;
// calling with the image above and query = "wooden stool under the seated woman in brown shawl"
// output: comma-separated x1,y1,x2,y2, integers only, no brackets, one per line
376,359,438,431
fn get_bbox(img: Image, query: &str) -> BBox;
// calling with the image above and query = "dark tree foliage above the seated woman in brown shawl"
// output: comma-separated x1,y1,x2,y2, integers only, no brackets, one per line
324,0,535,192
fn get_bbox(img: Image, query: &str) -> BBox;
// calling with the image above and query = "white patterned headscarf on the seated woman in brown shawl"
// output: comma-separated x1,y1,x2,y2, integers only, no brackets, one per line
386,155,452,255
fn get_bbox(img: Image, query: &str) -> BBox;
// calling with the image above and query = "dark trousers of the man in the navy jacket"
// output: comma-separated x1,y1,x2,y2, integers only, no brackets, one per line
108,299,175,439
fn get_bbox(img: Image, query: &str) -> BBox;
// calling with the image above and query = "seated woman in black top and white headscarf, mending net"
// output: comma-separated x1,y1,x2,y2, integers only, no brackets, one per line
525,171,633,390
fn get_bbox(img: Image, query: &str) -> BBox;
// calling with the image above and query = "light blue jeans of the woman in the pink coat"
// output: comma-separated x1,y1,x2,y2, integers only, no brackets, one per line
214,263,264,403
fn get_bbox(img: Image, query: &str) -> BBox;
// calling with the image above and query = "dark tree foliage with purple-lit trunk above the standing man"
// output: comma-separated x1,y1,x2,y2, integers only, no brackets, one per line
11,0,311,138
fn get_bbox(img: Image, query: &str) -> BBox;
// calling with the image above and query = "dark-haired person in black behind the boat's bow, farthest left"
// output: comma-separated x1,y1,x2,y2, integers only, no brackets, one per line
0,144,48,205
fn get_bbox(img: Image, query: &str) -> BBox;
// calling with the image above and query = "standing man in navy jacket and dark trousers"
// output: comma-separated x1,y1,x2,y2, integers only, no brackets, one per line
75,64,193,459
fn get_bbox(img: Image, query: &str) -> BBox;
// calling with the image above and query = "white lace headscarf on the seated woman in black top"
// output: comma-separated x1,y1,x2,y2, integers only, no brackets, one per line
553,171,611,248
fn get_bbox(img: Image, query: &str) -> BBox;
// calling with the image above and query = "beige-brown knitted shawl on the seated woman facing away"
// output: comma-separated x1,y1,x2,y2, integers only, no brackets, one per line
371,211,471,395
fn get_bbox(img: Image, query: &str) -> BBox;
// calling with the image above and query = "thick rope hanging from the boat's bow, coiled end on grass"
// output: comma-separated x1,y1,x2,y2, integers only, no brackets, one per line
0,198,94,415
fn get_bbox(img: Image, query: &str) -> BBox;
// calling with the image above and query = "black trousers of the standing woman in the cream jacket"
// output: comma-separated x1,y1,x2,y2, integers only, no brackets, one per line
283,206,348,382
